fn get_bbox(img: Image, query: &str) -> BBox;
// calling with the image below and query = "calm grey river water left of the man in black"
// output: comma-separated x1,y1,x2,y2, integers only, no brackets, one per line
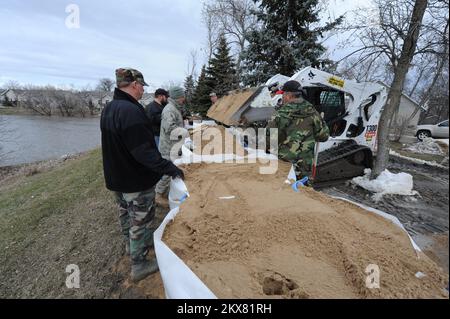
0,115,101,166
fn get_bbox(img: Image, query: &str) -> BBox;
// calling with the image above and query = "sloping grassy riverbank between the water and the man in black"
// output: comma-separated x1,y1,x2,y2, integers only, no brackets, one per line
0,149,167,298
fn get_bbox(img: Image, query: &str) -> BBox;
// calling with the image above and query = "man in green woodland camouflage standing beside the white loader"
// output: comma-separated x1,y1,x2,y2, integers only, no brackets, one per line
267,81,329,179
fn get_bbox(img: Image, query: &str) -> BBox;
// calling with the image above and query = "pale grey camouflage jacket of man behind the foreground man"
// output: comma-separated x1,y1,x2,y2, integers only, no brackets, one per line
159,99,184,159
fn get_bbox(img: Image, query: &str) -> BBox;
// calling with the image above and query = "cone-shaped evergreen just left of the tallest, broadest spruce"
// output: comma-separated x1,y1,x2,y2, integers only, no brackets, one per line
206,35,238,96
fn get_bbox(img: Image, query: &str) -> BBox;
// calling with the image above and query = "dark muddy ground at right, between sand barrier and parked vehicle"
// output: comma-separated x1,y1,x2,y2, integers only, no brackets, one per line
321,156,449,272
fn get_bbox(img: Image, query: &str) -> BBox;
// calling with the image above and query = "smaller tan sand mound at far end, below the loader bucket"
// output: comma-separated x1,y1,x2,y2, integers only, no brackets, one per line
191,125,247,156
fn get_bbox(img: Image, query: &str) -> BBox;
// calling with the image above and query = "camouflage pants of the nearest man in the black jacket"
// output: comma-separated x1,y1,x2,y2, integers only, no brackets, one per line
114,187,155,263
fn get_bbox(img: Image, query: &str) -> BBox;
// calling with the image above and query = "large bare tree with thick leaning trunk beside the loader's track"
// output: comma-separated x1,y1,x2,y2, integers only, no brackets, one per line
341,0,448,177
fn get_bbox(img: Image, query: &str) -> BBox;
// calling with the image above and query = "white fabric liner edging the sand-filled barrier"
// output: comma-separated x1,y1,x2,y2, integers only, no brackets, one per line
153,146,421,299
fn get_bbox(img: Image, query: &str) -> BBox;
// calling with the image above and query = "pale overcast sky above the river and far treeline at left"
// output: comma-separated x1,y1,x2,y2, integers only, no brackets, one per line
0,0,368,90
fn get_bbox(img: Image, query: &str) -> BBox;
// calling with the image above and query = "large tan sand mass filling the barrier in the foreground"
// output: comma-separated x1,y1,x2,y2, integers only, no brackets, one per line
163,162,448,298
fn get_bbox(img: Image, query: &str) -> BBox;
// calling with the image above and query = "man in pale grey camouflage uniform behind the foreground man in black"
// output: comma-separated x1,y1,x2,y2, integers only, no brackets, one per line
156,87,188,207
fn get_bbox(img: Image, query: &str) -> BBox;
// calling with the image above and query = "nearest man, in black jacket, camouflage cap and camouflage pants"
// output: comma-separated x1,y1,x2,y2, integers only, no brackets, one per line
100,68,184,281
